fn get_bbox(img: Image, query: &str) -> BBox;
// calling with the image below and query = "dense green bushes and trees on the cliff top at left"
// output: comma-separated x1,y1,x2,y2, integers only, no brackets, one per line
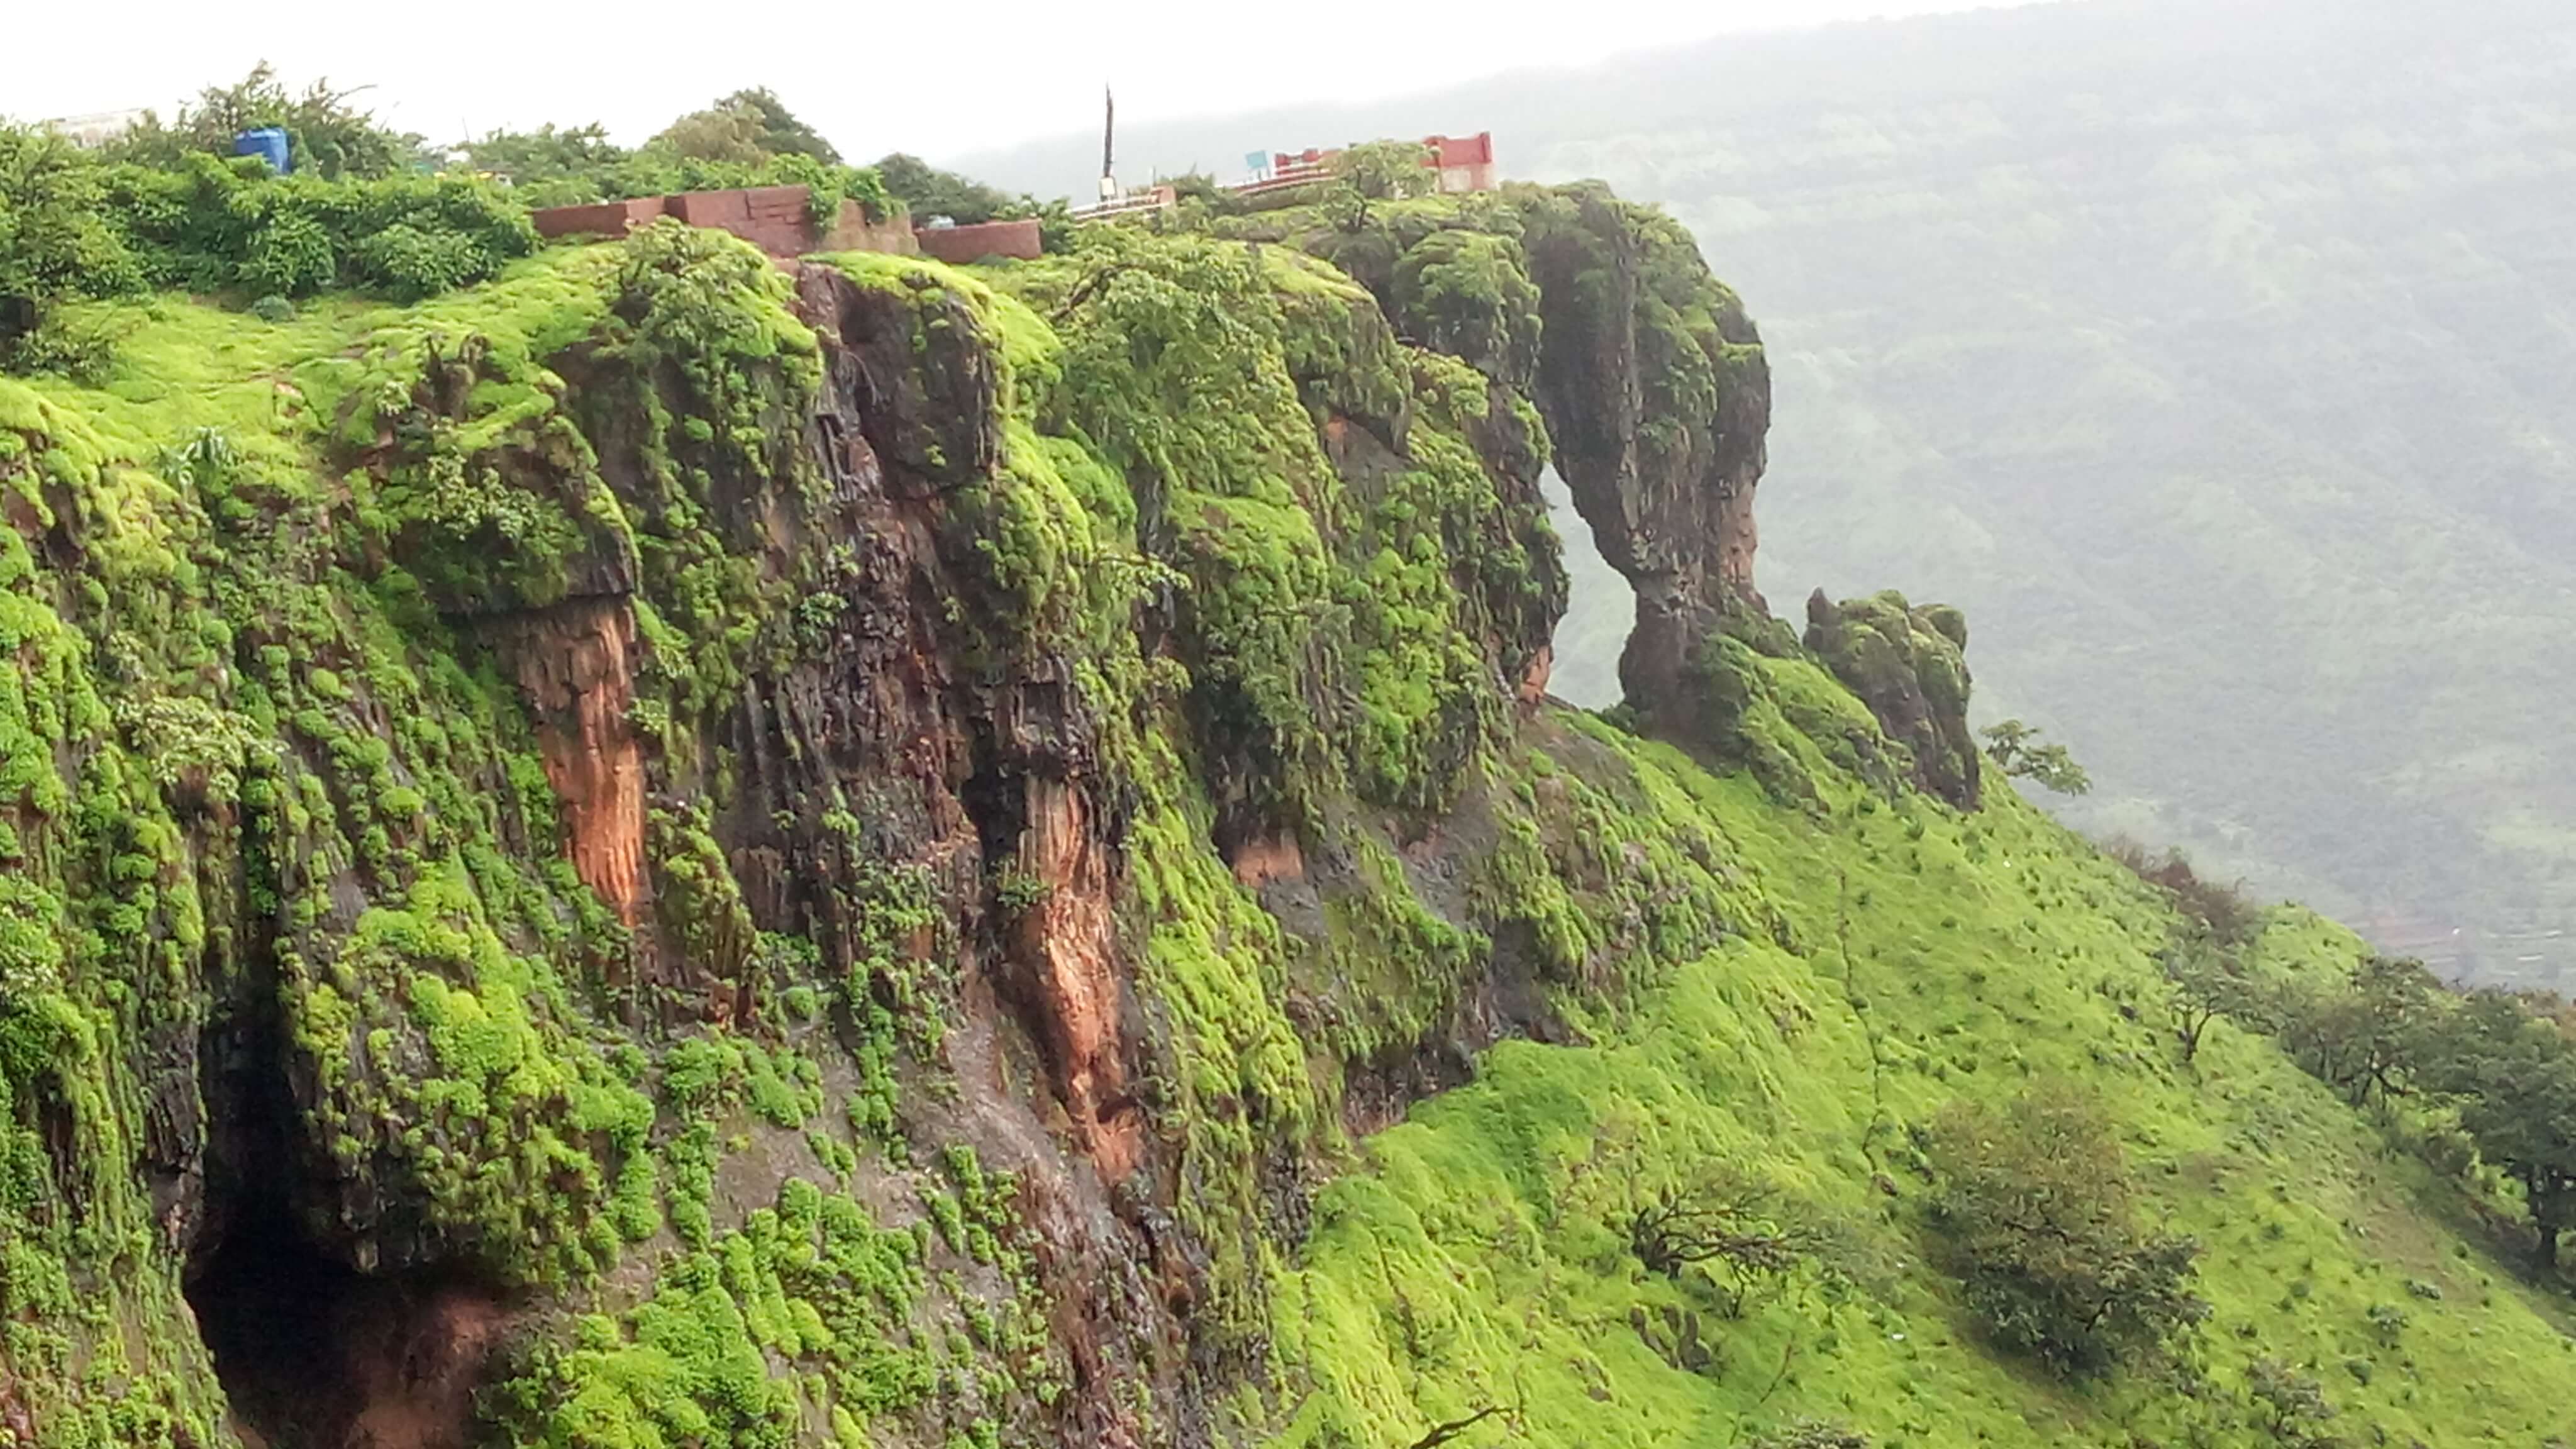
0,64,899,374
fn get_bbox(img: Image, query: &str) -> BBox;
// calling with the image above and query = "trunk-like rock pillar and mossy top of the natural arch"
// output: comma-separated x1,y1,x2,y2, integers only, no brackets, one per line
1241,186,1770,753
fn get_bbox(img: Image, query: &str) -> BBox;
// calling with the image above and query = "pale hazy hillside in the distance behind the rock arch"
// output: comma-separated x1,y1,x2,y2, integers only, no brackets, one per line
969,0,2576,980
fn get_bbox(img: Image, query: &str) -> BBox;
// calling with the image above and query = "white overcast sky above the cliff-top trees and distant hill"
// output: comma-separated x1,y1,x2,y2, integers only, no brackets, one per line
15,0,2009,160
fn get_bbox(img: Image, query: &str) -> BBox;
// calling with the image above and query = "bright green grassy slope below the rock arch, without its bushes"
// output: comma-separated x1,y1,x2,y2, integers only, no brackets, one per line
1267,686,2576,1449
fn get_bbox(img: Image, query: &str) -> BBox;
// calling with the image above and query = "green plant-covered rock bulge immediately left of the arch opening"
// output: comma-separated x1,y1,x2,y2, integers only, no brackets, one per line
1013,230,1563,830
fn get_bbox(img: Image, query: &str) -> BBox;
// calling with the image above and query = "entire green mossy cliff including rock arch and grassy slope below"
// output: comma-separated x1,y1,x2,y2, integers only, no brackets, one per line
0,188,2576,1449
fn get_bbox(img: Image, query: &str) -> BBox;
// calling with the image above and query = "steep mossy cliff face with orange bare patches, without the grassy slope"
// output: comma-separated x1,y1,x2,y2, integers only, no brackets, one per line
0,191,1974,1449
